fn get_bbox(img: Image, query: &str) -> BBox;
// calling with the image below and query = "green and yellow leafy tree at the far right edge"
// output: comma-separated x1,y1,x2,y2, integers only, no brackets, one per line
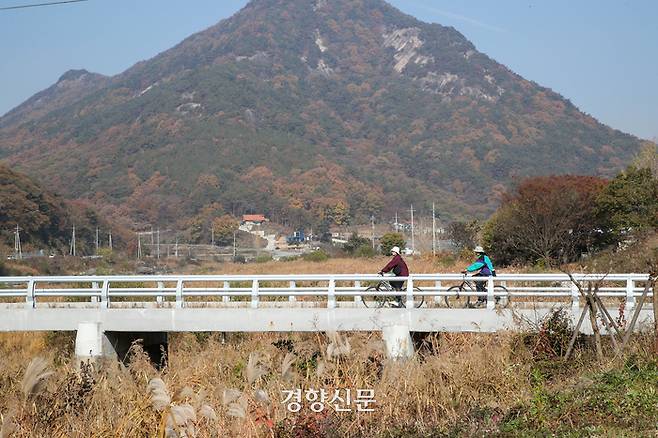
596,166,658,240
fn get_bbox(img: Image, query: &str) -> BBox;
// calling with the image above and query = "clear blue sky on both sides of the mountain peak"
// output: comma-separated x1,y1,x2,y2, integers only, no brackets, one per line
0,0,658,139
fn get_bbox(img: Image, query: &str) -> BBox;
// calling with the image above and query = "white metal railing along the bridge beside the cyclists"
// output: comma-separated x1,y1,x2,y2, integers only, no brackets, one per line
0,274,652,309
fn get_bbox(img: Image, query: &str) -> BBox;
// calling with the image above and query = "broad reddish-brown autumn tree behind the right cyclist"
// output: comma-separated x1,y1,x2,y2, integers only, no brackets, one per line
484,175,610,264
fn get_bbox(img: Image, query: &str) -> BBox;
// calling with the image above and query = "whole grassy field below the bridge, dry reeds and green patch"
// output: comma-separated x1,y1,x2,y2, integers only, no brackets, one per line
0,322,658,438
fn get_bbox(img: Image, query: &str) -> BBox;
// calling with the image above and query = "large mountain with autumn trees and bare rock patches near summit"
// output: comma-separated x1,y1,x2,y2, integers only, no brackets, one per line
0,0,641,233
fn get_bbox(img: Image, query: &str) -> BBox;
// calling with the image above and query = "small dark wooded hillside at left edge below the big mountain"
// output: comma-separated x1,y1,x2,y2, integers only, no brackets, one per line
0,164,115,254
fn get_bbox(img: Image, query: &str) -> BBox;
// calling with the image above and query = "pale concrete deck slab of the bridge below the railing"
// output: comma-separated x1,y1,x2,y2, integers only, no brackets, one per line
0,306,653,333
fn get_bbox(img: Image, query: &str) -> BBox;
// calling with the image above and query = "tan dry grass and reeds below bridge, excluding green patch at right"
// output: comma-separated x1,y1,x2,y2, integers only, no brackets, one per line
0,334,650,438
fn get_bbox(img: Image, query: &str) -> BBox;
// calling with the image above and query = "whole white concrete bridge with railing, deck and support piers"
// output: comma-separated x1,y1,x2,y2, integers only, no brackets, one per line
0,274,653,356
